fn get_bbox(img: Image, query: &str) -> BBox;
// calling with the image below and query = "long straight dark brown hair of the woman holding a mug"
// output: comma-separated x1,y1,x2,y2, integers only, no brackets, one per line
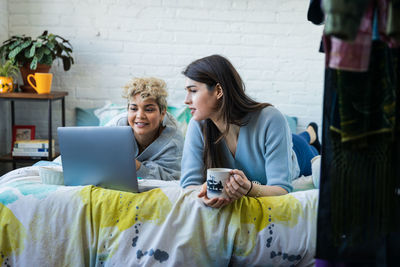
182,55,270,171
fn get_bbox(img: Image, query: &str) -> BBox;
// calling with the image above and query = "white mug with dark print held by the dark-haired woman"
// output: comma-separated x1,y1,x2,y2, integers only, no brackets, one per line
207,168,232,198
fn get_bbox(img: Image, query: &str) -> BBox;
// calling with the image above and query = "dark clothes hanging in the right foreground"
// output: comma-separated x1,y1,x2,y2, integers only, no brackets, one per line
316,0,400,266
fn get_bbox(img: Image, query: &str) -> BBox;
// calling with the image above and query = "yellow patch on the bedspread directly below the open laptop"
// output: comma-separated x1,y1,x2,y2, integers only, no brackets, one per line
79,186,172,262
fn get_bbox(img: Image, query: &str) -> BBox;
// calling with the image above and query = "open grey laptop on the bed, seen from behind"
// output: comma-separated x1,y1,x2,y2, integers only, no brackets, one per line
57,126,139,193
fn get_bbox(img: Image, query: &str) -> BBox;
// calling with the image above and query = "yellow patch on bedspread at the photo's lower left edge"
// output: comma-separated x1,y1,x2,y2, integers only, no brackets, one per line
0,203,26,265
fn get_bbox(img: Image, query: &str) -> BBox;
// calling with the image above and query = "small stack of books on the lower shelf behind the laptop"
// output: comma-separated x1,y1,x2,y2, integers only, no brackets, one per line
12,139,55,157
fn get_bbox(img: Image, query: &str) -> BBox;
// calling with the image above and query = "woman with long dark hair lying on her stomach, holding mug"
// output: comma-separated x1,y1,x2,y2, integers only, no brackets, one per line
181,55,319,208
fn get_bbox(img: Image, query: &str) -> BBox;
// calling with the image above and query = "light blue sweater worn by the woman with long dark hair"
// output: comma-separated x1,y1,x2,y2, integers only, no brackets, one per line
181,106,300,192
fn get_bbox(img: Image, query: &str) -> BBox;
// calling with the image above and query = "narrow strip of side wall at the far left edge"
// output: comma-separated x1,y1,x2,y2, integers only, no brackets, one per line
0,0,11,175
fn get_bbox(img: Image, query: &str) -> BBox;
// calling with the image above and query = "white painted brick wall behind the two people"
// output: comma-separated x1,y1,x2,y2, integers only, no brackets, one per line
7,0,324,140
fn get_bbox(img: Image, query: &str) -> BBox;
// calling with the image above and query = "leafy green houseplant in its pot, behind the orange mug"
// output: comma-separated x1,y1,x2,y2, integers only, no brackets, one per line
0,31,74,92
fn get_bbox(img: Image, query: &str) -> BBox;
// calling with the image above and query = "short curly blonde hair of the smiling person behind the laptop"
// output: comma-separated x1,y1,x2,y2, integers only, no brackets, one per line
123,77,168,112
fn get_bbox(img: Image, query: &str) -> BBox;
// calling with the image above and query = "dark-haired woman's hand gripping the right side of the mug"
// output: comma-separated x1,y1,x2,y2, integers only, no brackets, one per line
225,169,251,201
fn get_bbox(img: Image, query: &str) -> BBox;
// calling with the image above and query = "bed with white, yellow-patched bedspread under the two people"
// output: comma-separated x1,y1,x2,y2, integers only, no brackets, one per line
0,166,318,266
